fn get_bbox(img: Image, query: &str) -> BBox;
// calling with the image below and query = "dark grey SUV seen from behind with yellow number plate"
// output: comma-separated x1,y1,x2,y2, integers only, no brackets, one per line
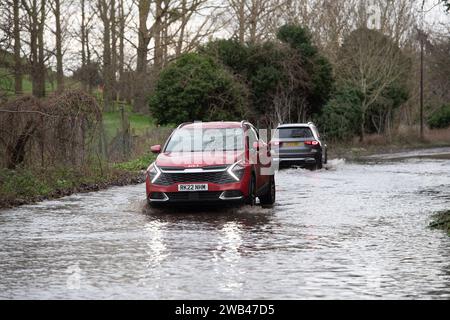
271,122,327,169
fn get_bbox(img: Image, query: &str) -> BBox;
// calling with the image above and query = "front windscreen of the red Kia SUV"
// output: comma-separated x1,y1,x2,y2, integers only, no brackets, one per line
165,128,244,152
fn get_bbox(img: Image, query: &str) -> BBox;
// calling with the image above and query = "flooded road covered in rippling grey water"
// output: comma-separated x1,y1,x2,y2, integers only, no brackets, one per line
0,150,450,299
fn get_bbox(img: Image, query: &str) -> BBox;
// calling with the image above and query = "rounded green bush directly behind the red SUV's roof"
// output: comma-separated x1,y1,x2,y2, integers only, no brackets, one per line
150,53,247,124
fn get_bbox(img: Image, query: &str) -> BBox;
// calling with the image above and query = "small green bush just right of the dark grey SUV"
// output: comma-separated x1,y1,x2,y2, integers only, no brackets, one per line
318,89,362,140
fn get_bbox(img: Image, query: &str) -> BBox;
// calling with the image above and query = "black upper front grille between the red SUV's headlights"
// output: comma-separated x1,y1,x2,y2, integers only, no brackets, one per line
155,171,236,186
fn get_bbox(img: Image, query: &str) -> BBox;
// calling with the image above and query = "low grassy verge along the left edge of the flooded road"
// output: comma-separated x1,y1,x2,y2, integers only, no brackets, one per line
0,154,155,208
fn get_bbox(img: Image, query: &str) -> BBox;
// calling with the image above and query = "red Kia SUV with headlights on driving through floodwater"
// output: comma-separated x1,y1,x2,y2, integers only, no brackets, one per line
146,121,275,205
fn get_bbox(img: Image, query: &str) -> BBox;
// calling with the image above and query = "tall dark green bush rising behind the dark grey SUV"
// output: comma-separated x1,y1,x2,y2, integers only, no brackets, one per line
199,29,334,125
